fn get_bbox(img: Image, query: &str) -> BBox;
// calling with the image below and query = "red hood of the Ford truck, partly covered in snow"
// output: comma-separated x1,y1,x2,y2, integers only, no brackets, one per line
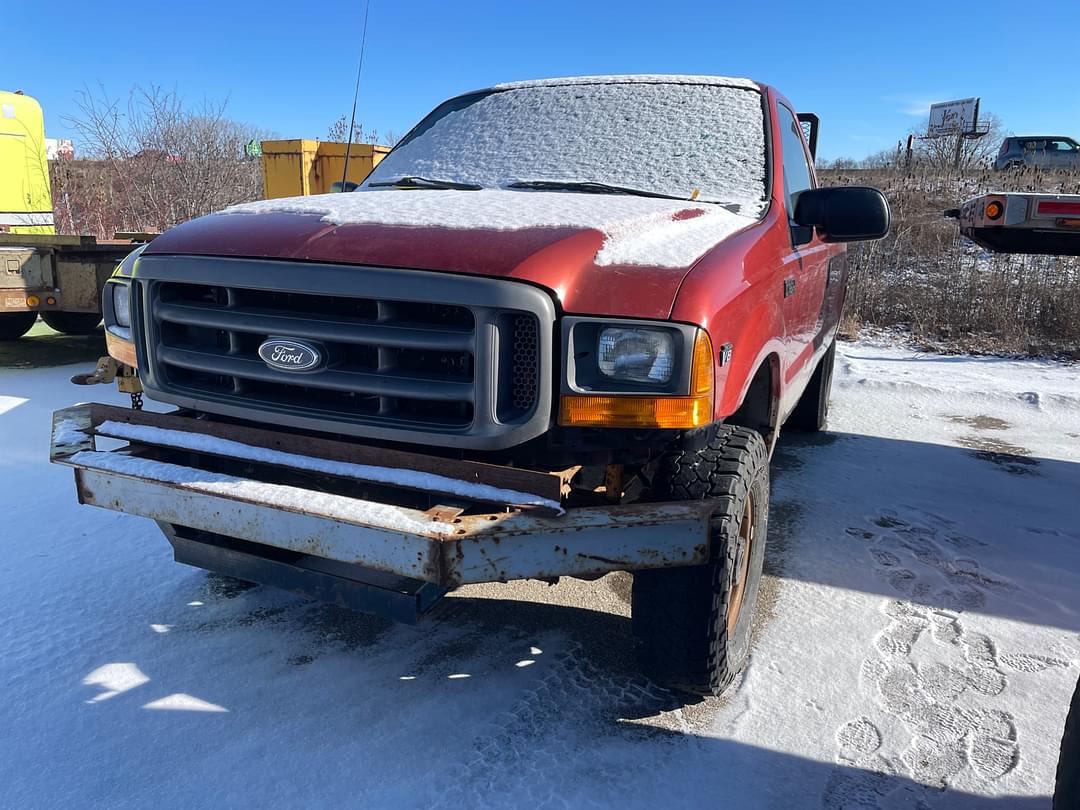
147,189,756,318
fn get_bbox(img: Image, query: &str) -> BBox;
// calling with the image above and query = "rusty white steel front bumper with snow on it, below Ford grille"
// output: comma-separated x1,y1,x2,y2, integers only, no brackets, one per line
51,405,714,590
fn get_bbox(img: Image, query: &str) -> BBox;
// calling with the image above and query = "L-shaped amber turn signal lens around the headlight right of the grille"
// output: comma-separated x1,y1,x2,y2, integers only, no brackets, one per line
558,330,714,430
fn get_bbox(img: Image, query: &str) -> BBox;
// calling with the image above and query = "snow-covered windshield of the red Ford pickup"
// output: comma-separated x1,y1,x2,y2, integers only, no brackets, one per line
364,82,766,216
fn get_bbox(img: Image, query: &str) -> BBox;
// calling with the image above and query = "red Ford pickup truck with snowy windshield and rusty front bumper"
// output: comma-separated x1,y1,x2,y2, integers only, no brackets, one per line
52,77,890,693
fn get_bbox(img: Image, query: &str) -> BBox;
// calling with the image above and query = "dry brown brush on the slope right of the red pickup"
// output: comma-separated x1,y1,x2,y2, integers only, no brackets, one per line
820,164,1080,357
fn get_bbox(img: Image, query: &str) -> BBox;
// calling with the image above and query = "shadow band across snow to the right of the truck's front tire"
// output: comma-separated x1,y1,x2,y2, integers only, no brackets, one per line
767,433,1080,632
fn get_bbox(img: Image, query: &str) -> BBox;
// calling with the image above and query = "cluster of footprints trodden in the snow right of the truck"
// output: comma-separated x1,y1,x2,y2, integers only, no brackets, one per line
822,511,1068,810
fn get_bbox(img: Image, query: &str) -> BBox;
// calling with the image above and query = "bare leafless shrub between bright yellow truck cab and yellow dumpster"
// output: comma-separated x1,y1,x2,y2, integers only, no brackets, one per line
58,86,264,235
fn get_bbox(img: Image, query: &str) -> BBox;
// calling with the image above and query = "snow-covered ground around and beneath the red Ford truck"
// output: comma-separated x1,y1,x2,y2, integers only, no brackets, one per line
0,334,1080,810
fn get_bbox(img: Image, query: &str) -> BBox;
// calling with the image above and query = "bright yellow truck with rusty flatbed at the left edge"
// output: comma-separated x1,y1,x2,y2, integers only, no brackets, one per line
0,91,147,340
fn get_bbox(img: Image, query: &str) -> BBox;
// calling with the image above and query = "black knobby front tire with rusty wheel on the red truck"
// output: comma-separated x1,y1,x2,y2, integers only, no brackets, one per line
631,424,769,696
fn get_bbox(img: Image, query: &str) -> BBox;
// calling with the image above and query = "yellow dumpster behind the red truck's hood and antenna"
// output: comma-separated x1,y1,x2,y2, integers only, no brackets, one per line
262,139,390,200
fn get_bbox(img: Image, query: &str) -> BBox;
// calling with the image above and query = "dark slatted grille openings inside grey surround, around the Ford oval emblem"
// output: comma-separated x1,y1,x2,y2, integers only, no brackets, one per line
151,282,501,428
